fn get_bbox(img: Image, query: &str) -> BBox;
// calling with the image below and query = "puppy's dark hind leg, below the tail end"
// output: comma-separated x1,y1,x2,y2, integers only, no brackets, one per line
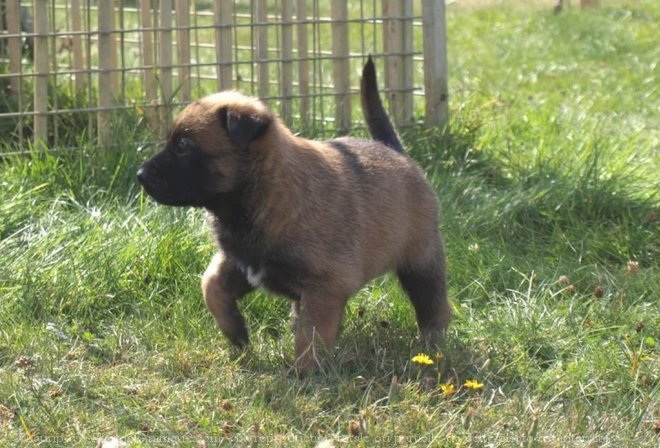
397,249,451,343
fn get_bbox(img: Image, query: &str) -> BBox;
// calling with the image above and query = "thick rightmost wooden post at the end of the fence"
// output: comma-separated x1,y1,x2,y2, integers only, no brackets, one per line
422,0,449,130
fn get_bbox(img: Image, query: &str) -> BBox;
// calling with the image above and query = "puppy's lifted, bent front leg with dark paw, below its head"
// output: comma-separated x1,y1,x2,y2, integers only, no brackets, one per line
202,253,253,347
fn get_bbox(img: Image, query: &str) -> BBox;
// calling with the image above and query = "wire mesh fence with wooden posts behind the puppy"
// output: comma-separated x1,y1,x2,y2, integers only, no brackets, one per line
0,0,447,149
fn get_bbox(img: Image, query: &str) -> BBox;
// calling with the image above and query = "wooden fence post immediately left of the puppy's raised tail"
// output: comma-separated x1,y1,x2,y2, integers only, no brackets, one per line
331,0,351,134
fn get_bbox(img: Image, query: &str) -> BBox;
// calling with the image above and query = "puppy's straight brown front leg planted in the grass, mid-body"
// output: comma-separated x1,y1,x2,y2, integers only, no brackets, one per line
295,295,347,375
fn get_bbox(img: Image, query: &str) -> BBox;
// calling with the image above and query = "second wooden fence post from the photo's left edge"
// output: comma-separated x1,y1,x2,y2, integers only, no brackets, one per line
33,0,49,145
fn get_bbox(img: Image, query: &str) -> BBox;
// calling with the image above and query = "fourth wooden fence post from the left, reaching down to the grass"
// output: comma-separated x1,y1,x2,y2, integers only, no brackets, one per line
96,0,114,147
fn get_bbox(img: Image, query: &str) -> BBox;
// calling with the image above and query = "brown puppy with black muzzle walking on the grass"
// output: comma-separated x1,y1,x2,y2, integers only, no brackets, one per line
138,58,451,373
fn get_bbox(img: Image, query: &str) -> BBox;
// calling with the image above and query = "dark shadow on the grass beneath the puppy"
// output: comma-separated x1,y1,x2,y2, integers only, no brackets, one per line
223,298,496,396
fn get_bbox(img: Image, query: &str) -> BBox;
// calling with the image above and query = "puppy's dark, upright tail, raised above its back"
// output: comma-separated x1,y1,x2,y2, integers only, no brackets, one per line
360,56,404,152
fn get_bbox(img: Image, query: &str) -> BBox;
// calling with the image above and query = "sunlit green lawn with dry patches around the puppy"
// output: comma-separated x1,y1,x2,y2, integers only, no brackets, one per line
0,1,660,447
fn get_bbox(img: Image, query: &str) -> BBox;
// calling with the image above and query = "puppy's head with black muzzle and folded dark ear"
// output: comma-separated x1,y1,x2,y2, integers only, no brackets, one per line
137,92,274,207
